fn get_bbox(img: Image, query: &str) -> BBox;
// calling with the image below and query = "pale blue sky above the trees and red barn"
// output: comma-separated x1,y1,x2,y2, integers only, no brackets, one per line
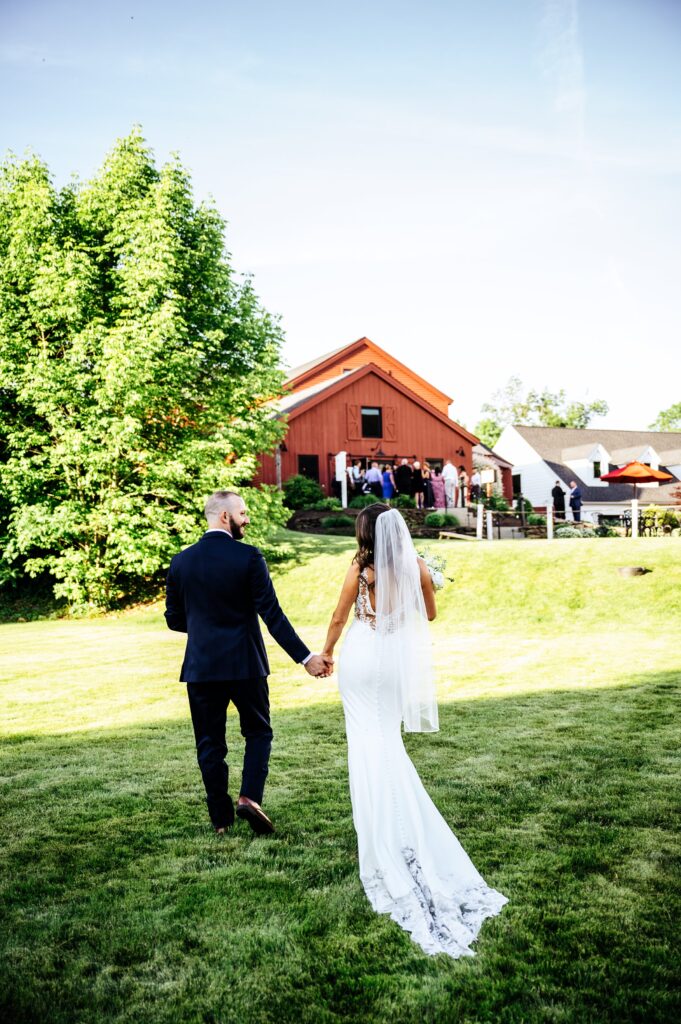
0,0,681,428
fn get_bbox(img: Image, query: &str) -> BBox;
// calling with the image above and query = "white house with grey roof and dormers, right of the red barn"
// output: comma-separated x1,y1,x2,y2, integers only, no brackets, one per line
495,426,681,521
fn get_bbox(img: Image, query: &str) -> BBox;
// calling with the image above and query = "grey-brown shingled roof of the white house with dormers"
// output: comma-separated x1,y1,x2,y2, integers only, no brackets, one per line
514,425,681,504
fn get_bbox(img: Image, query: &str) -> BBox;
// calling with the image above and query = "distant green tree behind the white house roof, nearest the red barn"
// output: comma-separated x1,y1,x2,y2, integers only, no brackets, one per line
475,377,607,447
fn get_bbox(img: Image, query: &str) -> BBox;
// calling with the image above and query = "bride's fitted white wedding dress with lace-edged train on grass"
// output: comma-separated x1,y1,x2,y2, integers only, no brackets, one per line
339,569,507,957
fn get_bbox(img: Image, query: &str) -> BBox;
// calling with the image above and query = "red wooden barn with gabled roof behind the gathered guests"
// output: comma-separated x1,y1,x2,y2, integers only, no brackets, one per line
257,338,510,495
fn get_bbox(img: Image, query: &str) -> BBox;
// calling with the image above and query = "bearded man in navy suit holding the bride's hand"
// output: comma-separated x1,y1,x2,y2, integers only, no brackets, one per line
166,490,333,835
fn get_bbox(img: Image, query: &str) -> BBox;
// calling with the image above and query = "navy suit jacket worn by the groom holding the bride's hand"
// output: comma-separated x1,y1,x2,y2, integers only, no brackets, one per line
166,530,309,683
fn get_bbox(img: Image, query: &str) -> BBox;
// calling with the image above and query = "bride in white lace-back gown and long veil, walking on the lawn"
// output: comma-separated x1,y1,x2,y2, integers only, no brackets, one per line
323,503,507,957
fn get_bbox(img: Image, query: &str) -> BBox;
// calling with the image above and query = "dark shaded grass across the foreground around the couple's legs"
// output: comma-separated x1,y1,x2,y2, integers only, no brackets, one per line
0,673,681,1024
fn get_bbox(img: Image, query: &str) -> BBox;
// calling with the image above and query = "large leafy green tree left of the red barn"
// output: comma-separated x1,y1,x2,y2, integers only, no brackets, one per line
0,130,283,606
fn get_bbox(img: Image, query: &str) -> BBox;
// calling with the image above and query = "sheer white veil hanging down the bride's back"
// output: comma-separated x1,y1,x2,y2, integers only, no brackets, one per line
374,509,439,732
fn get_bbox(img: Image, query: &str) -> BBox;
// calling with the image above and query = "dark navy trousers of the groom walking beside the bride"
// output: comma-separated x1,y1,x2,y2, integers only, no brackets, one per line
186,676,272,828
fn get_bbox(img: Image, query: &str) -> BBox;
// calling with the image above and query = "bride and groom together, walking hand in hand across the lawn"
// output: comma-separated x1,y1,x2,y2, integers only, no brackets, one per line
166,490,507,957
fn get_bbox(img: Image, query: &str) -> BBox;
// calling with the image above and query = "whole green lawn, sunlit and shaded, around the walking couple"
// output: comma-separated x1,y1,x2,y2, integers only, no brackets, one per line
0,537,681,1024
